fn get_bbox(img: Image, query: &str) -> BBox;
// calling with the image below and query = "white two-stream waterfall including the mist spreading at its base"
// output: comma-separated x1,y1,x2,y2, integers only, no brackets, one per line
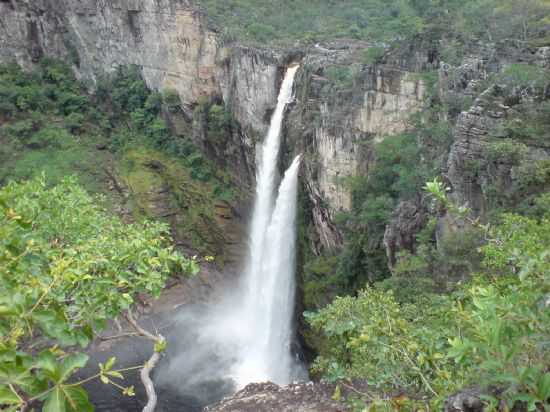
164,65,307,392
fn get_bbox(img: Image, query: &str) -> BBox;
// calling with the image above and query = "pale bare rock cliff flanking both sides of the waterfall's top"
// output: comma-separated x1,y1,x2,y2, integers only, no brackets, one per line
0,0,432,254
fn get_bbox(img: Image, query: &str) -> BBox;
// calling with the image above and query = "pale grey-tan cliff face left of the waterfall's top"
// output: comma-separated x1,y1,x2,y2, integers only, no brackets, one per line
0,0,280,190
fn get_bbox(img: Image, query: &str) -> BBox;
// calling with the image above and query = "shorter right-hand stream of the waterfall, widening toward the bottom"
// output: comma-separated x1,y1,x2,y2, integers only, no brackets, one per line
233,156,300,386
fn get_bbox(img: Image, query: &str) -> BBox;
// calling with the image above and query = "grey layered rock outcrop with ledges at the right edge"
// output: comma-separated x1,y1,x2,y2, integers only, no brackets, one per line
439,44,550,225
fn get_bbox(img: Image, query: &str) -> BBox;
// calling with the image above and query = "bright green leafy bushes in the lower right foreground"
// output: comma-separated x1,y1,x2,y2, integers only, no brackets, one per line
306,214,550,410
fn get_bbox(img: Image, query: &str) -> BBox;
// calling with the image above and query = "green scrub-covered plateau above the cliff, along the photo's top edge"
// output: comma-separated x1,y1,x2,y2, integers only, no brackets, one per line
198,0,550,45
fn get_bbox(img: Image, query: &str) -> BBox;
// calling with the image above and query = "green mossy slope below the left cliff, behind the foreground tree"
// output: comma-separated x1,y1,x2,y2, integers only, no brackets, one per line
0,59,234,264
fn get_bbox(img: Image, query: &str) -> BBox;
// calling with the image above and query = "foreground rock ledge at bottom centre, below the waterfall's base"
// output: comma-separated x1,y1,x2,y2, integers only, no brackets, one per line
205,382,351,412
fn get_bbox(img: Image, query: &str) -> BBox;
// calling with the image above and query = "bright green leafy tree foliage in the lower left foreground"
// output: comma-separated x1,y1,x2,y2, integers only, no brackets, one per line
0,177,197,412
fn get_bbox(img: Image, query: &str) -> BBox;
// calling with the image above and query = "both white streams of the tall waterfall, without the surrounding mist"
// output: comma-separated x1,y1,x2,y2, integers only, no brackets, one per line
233,66,300,386
